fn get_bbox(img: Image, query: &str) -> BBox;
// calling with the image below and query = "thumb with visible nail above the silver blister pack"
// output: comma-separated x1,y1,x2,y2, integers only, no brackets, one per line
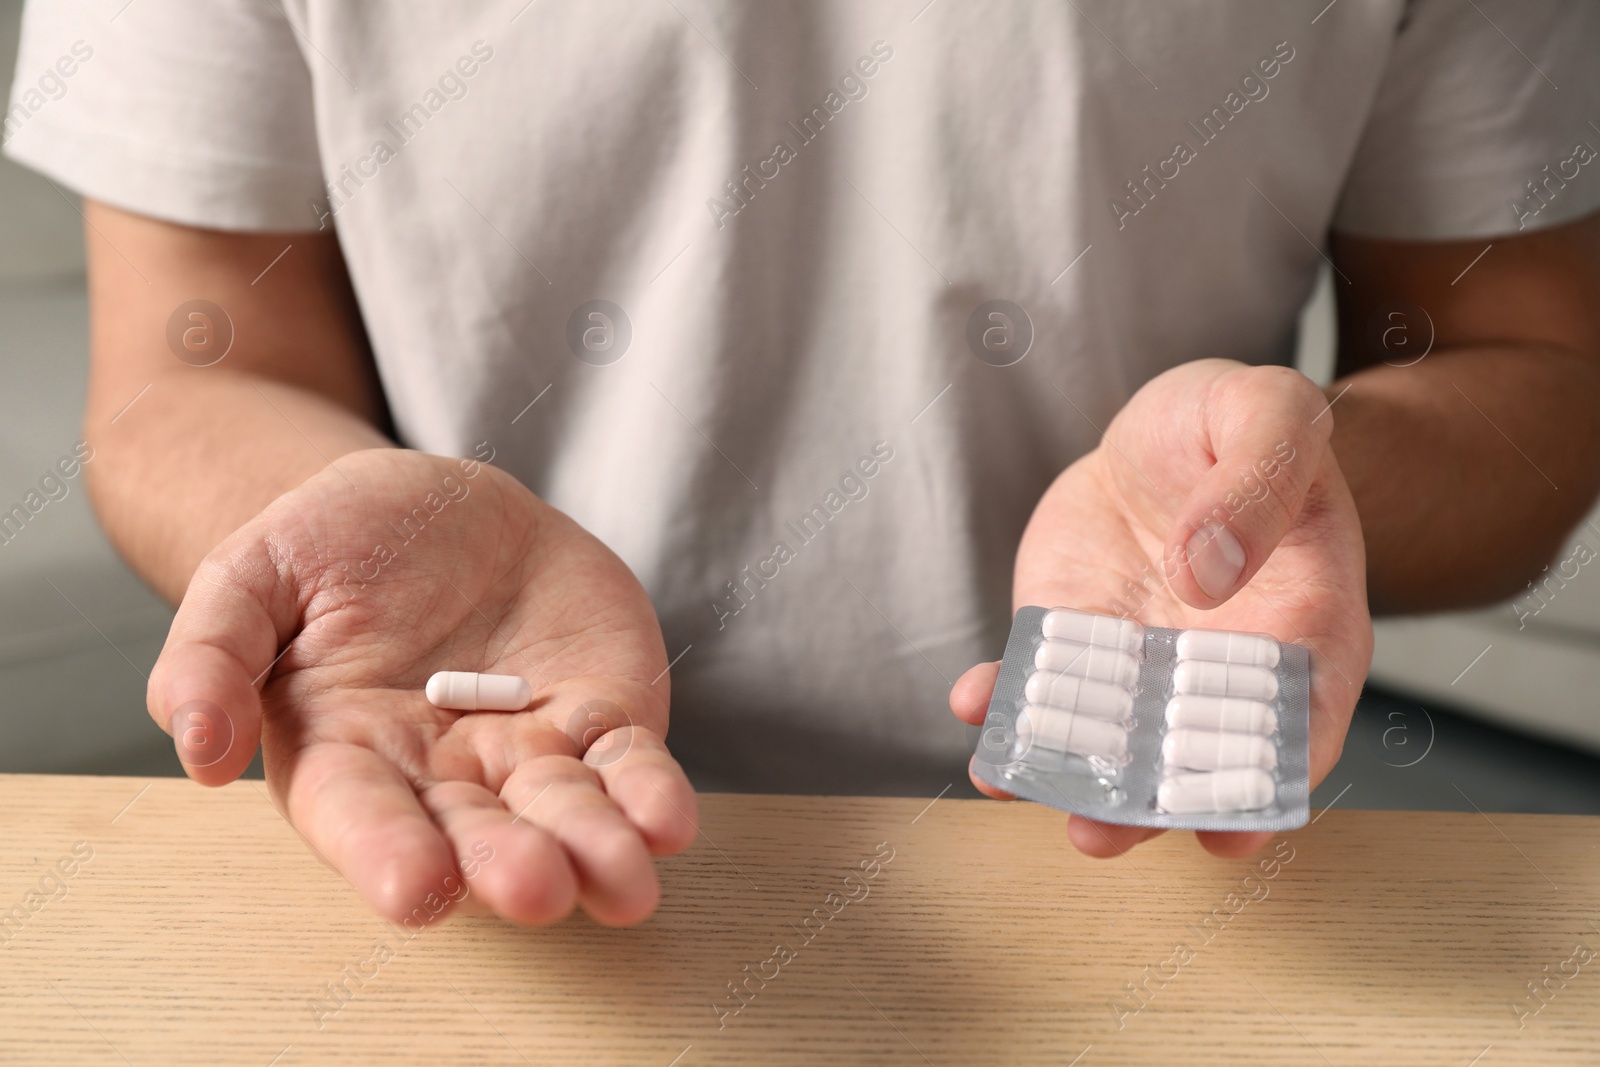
1165,366,1333,608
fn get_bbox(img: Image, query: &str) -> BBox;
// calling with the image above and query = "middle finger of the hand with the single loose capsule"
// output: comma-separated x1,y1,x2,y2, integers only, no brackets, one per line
419,782,578,925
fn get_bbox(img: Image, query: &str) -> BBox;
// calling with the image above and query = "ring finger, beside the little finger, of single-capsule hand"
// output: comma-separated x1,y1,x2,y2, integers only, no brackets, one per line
501,755,661,926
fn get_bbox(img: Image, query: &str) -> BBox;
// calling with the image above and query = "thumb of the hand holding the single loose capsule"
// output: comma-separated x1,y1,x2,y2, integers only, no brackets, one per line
146,541,299,785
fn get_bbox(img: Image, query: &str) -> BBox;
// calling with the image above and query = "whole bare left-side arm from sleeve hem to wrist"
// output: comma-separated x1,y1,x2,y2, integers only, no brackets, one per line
85,202,390,603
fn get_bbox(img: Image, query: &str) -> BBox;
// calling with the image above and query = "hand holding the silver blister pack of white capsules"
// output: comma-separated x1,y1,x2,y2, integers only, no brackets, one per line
950,360,1373,856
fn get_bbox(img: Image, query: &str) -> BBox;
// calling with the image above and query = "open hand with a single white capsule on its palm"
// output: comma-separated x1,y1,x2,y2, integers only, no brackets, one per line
149,448,696,925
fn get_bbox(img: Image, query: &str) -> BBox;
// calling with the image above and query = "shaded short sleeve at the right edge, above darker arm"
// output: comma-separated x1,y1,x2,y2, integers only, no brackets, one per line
1330,0,1600,240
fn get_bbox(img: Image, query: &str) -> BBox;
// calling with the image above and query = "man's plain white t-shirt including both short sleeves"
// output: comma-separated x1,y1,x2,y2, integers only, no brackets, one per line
6,0,1600,795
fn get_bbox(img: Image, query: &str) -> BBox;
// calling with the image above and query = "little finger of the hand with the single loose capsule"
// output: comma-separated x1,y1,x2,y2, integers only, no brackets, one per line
584,726,699,856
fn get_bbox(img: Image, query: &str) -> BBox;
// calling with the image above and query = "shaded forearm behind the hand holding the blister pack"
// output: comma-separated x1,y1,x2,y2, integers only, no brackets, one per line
1328,346,1600,613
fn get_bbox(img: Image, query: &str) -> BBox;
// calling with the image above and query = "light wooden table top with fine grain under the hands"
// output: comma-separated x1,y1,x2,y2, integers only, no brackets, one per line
0,776,1600,1067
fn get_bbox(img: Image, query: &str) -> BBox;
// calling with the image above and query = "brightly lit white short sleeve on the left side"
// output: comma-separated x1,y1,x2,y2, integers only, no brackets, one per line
5,0,323,230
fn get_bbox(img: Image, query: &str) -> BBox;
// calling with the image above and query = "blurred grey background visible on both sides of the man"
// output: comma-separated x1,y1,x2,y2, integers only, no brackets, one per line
0,0,1600,814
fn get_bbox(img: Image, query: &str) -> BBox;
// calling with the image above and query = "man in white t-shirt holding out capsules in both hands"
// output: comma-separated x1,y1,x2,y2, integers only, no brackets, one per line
10,0,1600,923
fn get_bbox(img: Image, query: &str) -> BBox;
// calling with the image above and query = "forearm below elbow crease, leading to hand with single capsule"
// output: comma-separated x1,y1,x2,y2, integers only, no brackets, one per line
85,368,392,603
